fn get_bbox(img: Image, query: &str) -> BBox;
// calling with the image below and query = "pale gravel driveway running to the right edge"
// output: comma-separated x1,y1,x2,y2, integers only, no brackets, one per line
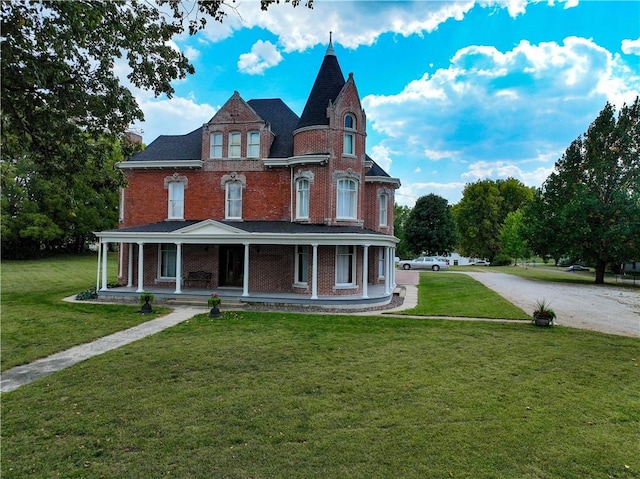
466,272,640,337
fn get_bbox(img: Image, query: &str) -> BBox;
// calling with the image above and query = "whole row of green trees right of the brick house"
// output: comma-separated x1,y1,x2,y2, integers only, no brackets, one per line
394,98,640,283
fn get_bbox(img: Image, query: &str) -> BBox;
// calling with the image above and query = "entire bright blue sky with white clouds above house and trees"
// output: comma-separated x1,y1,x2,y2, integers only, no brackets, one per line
125,0,640,206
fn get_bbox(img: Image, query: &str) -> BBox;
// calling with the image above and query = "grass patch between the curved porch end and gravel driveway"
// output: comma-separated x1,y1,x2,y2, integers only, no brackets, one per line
401,272,531,319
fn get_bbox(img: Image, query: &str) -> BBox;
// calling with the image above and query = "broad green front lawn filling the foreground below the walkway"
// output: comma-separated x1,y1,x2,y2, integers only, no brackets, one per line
0,258,640,479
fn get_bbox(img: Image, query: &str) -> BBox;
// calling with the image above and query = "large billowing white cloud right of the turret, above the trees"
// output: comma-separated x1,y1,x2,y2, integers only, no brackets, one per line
363,37,640,193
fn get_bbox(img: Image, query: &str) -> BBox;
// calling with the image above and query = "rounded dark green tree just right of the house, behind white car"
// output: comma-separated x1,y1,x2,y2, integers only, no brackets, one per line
405,194,456,255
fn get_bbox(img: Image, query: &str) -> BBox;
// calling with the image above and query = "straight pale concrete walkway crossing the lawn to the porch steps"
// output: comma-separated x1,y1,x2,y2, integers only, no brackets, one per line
0,307,206,393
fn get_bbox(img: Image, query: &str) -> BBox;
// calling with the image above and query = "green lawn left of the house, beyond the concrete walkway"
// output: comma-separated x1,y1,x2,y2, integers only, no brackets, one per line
0,255,169,371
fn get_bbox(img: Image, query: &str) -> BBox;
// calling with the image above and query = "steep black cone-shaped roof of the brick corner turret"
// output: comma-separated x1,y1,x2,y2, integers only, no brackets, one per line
298,51,345,128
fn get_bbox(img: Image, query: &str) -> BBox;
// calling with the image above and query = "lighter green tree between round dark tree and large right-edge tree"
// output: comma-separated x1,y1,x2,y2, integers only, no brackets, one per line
453,178,533,261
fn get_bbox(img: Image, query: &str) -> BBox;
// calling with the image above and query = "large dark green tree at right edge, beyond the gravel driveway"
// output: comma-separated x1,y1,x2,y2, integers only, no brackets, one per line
528,98,640,283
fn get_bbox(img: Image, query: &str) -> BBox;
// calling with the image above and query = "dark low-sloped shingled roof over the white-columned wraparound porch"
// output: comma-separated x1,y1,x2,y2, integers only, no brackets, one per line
110,220,383,235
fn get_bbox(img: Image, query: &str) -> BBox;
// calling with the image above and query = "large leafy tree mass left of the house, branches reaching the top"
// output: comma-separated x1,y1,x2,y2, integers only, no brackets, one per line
0,0,312,256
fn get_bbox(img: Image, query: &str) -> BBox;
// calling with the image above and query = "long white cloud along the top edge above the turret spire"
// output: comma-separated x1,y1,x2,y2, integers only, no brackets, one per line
194,0,578,53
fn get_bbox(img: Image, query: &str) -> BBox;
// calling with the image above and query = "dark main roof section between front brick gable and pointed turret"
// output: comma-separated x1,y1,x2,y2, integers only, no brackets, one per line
247,98,299,158
